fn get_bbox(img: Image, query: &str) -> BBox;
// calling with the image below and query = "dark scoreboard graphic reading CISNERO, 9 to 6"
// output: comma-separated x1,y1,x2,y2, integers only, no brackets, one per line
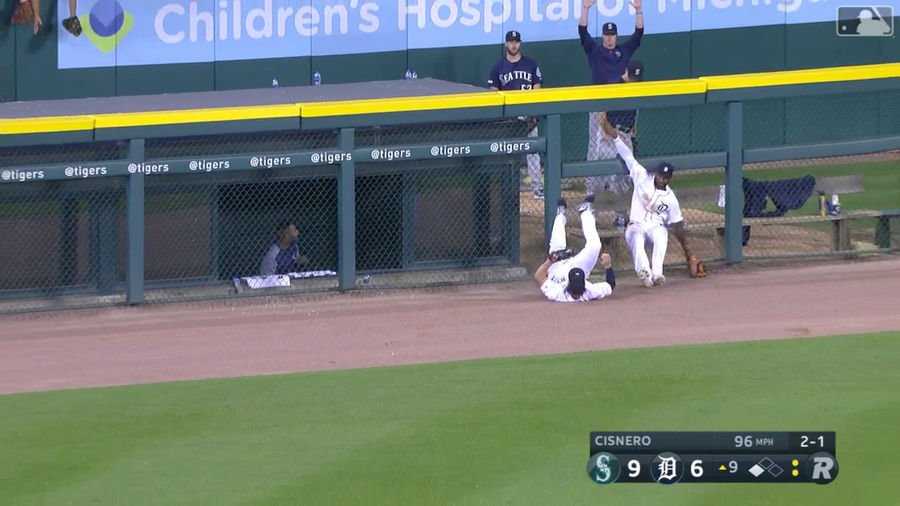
587,431,838,485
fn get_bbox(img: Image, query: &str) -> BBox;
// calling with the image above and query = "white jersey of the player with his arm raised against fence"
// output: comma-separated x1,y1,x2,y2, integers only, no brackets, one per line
615,138,684,226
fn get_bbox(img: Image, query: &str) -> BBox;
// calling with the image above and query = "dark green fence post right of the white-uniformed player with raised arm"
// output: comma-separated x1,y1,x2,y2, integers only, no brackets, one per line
725,102,744,264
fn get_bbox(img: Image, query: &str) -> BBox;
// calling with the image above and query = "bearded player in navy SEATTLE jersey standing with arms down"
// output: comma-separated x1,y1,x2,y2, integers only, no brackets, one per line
488,30,544,199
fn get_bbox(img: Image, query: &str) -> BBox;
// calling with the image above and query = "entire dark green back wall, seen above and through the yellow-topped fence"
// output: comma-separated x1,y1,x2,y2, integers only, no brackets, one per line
0,9,900,160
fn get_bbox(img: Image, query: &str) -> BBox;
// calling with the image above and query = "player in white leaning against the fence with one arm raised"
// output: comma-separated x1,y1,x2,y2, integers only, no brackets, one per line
600,114,706,288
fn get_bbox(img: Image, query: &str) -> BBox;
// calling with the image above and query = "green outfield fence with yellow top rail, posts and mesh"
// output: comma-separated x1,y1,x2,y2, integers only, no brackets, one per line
0,64,900,311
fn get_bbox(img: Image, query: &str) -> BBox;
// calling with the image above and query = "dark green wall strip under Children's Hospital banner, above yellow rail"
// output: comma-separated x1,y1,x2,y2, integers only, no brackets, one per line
0,20,900,100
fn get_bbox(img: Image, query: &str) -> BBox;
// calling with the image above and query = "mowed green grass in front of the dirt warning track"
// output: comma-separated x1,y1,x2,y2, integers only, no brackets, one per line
0,332,900,506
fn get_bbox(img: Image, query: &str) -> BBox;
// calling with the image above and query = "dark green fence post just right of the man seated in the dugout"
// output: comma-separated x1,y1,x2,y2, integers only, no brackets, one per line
337,128,356,291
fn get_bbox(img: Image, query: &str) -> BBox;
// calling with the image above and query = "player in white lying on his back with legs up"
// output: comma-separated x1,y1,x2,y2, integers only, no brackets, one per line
534,195,616,302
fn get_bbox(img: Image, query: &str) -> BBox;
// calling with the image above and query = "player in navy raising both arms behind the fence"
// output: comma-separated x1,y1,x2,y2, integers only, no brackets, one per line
578,0,644,194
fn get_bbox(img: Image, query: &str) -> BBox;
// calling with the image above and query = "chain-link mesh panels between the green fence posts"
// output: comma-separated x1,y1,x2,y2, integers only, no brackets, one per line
0,92,900,311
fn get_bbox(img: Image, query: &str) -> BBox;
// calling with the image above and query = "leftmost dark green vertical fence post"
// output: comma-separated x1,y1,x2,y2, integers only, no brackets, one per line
125,139,145,304
